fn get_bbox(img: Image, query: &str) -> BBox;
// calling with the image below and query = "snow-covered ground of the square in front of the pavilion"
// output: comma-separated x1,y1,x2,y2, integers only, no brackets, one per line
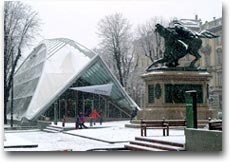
4,121,185,151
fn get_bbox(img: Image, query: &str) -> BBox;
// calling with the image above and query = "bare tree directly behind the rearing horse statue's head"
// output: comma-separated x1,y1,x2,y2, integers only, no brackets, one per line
137,17,166,62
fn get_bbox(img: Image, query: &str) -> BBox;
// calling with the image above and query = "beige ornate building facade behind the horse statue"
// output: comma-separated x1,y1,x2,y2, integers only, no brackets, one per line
170,15,223,111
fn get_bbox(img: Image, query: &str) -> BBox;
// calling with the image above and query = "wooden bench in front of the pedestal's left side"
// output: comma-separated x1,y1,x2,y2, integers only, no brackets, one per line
141,119,169,136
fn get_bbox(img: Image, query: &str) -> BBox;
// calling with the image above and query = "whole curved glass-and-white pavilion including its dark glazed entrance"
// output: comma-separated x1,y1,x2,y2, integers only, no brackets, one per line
8,38,139,121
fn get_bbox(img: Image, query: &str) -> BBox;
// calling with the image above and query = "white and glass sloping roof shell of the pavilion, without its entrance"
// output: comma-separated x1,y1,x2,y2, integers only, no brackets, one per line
8,38,139,121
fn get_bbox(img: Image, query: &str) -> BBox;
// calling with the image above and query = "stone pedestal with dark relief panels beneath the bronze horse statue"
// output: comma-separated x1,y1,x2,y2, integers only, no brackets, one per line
137,68,217,120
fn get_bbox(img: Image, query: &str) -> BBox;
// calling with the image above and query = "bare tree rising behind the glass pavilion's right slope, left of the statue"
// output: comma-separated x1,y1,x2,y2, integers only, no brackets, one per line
98,13,134,87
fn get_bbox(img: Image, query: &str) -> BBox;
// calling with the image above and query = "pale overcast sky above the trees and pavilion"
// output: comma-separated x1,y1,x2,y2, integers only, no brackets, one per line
25,0,222,49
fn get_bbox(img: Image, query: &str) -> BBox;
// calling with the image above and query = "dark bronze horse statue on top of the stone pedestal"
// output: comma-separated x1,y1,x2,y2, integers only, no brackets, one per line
147,23,218,70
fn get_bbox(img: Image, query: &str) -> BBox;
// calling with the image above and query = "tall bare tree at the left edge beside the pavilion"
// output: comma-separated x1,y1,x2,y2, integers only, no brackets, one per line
4,1,40,124
